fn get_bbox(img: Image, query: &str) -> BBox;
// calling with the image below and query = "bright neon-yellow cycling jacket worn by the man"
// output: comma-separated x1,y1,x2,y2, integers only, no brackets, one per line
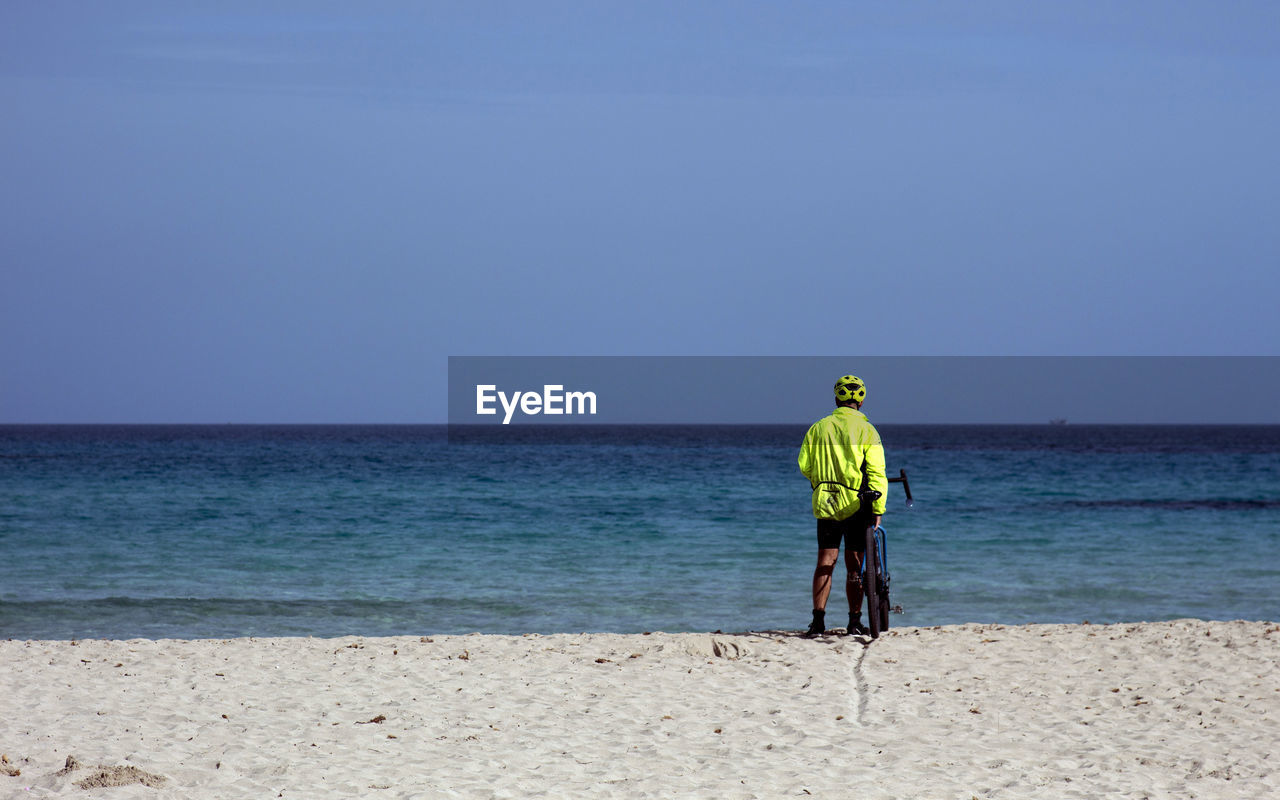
797,406,888,520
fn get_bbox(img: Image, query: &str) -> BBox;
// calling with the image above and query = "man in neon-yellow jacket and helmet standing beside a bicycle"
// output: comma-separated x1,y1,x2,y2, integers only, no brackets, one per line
799,375,888,636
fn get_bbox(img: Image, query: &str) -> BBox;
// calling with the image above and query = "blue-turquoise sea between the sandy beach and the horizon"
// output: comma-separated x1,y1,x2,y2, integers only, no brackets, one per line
0,424,1280,639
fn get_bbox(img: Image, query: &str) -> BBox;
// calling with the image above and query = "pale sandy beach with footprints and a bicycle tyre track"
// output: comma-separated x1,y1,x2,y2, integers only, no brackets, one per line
0,620,1280,800
